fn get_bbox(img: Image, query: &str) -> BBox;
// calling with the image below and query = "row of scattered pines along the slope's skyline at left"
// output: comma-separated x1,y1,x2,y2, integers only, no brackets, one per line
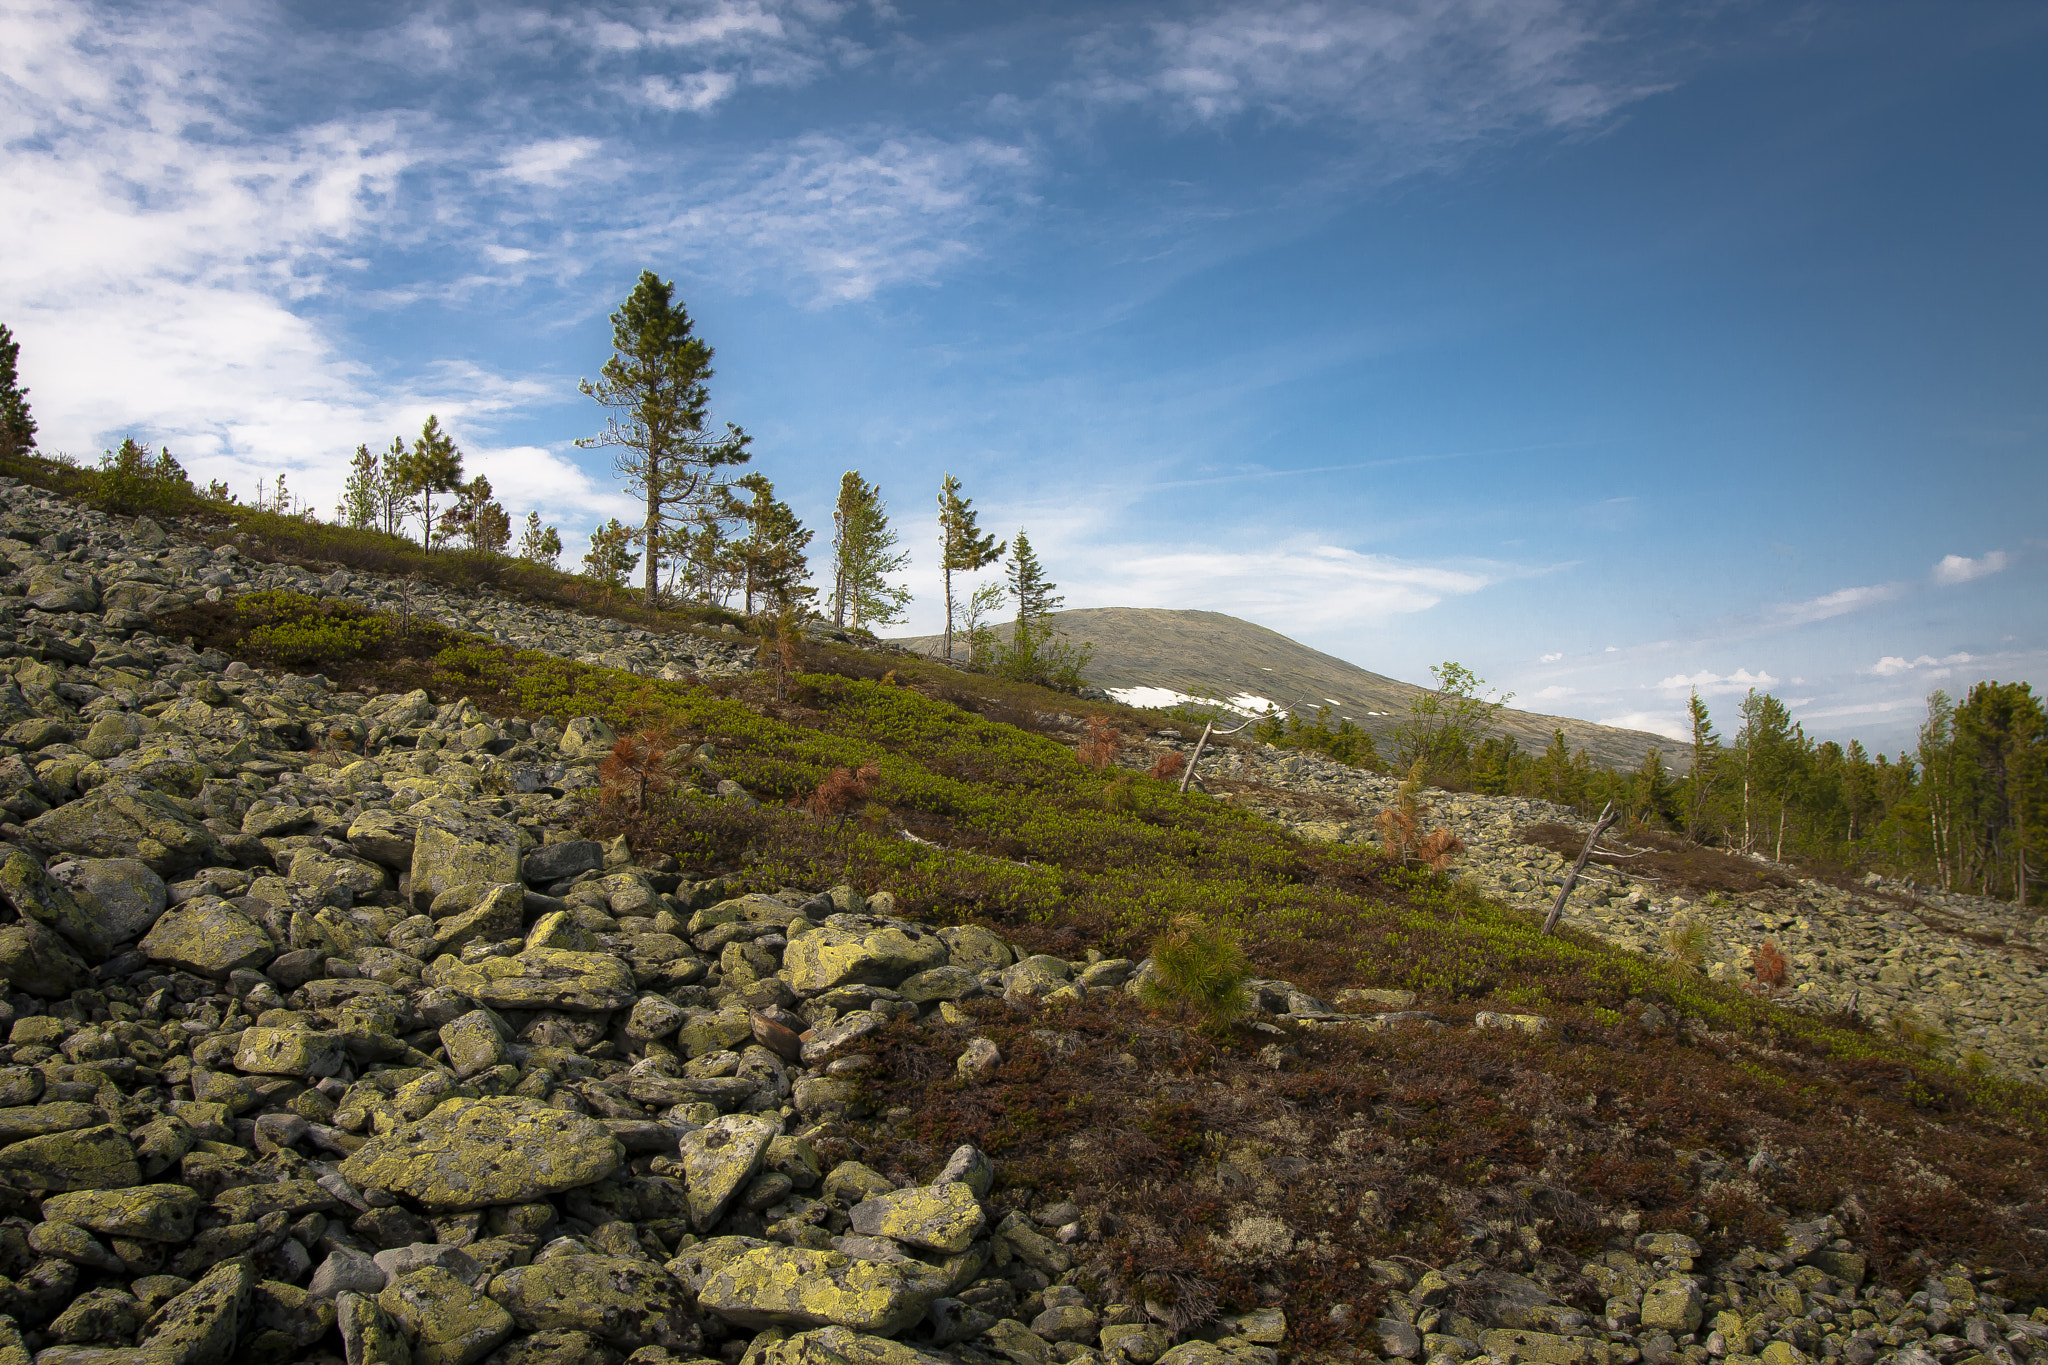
0,270,1090,690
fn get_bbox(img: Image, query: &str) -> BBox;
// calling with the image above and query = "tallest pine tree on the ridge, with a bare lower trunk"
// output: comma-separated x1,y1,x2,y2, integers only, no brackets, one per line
575,270,752,610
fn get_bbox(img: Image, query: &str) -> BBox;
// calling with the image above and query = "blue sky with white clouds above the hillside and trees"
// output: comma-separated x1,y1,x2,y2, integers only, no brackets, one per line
0,0,2048,751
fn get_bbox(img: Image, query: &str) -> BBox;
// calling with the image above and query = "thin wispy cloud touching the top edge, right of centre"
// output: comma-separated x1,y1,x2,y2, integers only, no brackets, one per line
1083,0,1653,160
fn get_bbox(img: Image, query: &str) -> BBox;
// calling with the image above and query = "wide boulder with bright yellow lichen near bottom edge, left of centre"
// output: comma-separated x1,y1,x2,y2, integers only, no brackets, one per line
696,1246,938,1336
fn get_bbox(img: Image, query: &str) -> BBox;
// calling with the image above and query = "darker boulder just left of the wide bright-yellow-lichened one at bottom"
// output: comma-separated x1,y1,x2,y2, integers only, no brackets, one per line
489,1254,702,1355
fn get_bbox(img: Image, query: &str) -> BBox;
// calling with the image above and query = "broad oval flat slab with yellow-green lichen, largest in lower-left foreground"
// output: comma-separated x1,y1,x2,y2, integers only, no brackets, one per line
342,1095,627,1212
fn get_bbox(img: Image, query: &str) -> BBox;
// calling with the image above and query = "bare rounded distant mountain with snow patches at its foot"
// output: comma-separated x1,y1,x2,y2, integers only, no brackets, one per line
893,606,1683,767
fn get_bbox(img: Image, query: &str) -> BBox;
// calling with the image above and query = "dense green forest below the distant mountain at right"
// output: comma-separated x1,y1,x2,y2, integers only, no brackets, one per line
1251,663,2048,905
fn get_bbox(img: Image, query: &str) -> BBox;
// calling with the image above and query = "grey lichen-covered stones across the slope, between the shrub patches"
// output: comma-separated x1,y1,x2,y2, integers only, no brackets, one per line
0,483,2048,1365
